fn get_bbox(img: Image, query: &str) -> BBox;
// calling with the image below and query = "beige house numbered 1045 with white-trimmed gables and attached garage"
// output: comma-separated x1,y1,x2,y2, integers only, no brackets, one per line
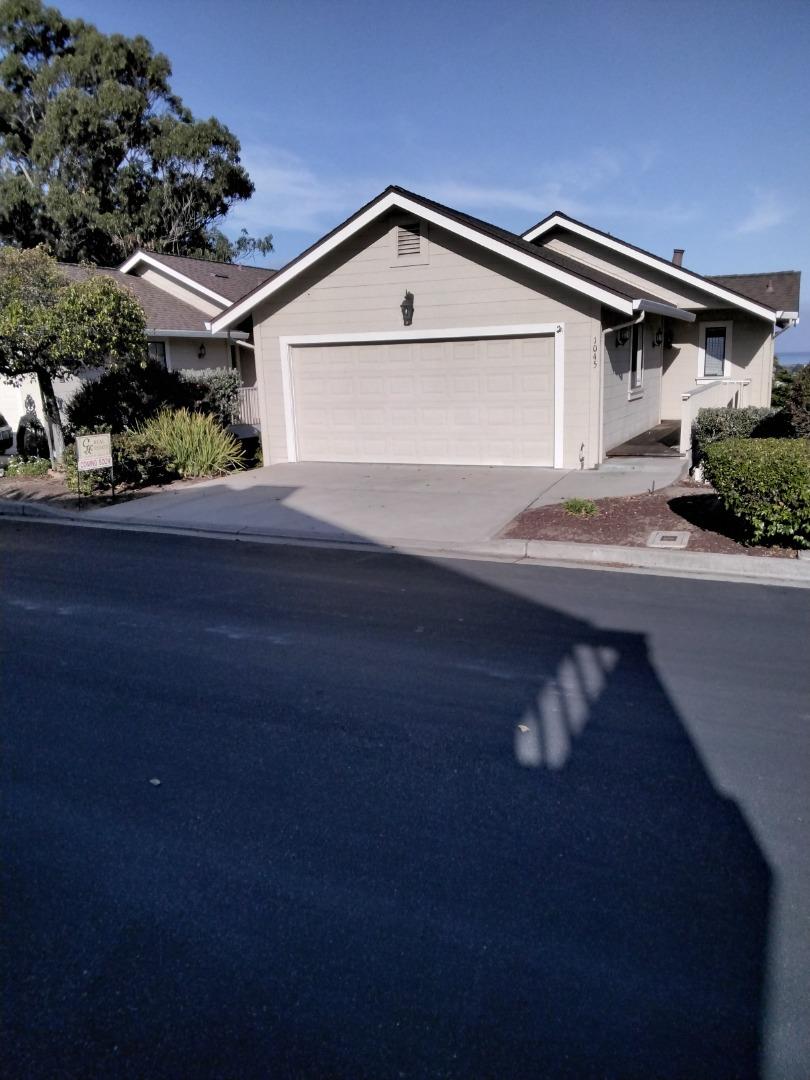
207,187,799,468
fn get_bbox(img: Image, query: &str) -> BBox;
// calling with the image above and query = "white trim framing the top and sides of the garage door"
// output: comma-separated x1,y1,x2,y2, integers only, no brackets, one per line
279,323,565,469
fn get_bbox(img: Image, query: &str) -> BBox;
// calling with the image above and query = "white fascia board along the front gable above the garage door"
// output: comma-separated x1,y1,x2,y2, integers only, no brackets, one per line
211,191,633,330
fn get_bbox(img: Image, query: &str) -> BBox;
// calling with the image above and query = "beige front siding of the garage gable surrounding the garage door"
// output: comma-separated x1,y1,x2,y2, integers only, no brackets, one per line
254,214,600,468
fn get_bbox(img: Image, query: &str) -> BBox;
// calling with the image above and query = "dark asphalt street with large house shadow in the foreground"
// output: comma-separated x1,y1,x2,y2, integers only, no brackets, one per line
0,521,810,1080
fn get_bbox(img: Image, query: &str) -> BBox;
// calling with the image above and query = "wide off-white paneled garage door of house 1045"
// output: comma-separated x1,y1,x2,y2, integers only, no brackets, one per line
292,335,554,465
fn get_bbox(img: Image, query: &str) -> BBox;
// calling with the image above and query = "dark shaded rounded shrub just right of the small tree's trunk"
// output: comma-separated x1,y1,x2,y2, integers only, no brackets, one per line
66,361,201,434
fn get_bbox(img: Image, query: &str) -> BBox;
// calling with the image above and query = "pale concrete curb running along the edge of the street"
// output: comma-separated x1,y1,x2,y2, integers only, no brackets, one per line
0,499,810,589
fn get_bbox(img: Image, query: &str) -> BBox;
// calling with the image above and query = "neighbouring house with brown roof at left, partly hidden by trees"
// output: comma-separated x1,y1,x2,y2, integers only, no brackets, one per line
0,251,273,449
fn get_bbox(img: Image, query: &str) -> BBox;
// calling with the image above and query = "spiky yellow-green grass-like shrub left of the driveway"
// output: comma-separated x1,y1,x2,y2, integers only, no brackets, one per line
139,409,244,476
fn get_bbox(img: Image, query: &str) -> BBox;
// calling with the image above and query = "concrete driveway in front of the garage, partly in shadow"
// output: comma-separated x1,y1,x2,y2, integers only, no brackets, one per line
87,462,568,544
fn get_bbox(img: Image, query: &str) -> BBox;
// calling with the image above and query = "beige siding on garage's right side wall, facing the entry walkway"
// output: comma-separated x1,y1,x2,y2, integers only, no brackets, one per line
603,319,663,451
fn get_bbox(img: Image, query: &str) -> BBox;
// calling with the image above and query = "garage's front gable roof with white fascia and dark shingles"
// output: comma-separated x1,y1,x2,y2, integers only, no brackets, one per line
210,185,694,330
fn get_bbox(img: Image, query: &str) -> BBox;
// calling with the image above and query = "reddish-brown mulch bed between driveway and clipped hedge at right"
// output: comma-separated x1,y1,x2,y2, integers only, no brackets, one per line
502,485,796,558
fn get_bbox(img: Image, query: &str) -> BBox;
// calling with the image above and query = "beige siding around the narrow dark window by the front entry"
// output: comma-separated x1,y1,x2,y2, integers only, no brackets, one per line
661,308,773,419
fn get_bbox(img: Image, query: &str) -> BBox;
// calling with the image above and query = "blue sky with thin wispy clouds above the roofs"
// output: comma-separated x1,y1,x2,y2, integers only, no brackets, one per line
68,0,810,351
